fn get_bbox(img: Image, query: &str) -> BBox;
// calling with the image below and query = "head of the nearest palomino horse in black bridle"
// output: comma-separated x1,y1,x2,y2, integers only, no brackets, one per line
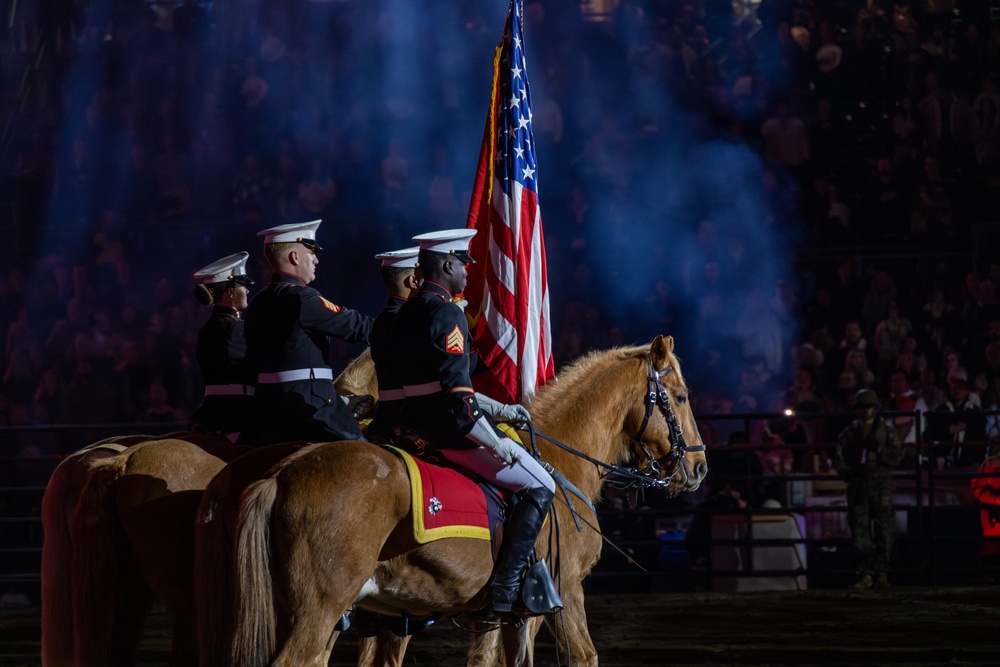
626,336,708,495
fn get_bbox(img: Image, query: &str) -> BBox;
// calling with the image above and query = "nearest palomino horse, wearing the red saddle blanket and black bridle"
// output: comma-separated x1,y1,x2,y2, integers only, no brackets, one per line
233,336,708,667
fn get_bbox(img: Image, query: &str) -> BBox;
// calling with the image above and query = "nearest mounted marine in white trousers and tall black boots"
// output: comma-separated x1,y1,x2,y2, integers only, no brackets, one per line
390,229,562,613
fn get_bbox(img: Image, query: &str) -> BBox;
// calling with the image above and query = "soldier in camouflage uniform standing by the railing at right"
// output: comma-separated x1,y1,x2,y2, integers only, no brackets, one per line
837,389,903,589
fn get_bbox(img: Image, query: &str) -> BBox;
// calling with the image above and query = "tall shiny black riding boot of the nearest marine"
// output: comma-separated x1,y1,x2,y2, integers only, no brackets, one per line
489,486,552,613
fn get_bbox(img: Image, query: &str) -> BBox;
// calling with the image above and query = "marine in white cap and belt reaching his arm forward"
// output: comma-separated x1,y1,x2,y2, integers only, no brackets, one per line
239,220,372,446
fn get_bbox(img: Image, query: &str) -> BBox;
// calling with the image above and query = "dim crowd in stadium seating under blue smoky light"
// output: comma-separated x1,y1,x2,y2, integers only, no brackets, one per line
0,0,1000,470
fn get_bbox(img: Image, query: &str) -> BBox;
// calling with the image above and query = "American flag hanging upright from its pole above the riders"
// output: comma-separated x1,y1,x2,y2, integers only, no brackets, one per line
466,0,555,401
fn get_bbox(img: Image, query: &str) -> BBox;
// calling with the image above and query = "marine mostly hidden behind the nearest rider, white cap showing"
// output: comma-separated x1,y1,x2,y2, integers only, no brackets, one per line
368,246,420,440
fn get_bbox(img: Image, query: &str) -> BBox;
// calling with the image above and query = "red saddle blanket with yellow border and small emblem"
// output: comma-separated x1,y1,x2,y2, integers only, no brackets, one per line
386,445,490,544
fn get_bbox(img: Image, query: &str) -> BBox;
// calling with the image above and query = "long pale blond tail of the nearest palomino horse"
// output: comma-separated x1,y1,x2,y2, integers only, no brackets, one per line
233,477,278,667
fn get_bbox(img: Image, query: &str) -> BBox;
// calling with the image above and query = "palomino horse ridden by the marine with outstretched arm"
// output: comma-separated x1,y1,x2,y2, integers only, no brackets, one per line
58,350,377,667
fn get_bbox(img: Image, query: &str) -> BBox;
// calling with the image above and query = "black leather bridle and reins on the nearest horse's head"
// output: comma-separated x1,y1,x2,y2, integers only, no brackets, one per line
528,354,705,497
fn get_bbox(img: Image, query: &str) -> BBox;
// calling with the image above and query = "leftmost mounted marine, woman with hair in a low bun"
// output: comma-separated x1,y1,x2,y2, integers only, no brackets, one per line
191,252,256,440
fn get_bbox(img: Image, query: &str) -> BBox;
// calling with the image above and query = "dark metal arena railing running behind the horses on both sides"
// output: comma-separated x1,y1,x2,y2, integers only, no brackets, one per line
0,411,1000,599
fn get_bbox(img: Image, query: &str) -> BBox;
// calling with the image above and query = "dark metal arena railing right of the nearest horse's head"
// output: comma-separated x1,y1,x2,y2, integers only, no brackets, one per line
587,410,1000,592
